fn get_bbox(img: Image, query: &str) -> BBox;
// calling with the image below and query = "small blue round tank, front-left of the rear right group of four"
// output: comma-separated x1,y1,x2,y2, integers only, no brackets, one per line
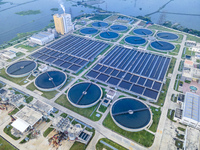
124,36,146,45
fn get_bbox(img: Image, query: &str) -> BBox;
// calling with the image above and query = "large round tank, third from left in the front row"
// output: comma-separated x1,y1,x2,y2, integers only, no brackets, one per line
67,82,102,108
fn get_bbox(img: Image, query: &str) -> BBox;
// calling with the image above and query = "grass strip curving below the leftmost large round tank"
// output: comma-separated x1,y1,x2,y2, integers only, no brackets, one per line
0,68,27,85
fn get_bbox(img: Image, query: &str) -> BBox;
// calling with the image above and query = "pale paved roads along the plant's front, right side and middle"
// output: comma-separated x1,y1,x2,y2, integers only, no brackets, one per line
0,16,189,150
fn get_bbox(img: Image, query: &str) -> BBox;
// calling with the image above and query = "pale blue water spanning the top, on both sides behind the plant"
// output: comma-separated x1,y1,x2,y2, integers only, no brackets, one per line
0,0,200,44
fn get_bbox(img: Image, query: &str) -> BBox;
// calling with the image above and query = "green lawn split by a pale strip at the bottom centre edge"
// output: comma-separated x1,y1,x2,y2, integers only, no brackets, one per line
96,138,127,150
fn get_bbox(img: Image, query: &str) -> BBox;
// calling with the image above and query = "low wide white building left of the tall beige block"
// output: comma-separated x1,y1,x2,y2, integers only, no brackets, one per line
30,32,55,45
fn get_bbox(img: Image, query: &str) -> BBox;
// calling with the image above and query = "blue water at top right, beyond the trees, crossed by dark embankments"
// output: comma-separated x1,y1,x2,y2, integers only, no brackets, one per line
96,0,200,30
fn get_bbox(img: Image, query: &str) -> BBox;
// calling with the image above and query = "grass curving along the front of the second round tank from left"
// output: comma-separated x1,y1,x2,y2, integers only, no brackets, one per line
26,82,58,99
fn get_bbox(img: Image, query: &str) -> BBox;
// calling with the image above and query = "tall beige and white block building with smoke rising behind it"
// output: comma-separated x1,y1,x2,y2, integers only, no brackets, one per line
53,13,74,35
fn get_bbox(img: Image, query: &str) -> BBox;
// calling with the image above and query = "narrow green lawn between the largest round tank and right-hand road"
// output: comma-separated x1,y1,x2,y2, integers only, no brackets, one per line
149,107,161,132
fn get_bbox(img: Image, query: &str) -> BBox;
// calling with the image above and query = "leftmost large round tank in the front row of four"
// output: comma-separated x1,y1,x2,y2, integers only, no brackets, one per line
6,60,37,78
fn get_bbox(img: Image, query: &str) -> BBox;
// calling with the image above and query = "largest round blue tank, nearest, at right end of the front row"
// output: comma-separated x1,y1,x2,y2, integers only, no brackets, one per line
110,98,152,132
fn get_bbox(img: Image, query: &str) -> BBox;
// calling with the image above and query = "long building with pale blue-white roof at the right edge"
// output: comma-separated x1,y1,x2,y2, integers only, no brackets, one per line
181,92,200,129
